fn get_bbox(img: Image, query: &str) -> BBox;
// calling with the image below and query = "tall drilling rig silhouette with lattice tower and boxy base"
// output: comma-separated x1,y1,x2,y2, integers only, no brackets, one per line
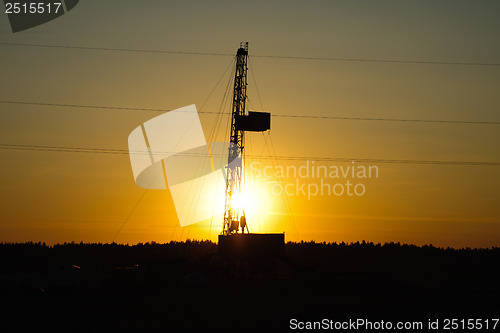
219,42,285,266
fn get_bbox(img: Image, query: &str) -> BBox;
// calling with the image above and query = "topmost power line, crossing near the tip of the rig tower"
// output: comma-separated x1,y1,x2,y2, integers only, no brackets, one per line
0,42,500,67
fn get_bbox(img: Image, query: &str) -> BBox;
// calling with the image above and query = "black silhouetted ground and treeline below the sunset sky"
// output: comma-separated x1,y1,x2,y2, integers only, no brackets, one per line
0,242,500,332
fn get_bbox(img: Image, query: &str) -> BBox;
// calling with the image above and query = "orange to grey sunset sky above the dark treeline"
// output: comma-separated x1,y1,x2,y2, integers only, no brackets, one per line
0,0,500,247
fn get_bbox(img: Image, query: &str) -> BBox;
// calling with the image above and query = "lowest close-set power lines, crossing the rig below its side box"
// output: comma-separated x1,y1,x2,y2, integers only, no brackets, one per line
0,143,500,166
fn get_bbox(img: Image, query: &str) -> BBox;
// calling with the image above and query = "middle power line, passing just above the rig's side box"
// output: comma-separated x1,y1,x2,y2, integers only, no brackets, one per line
0,100,500,125
